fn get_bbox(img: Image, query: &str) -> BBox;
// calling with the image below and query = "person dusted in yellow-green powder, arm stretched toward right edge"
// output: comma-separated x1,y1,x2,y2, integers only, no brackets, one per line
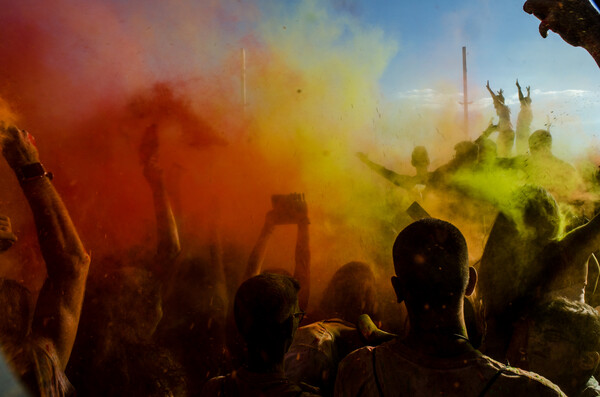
477,186,600,362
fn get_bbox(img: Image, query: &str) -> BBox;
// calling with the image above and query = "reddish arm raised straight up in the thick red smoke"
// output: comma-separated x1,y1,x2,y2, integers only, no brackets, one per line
139,124,181,282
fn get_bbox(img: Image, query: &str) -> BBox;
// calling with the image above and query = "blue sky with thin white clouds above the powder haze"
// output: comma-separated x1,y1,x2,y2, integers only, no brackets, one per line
251,0,600,157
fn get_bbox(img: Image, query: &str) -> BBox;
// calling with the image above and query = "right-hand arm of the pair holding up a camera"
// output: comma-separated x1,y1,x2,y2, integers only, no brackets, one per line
294,195,310,310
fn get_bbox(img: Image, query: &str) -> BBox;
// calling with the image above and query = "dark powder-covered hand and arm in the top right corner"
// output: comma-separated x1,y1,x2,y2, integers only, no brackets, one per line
523,0,600,66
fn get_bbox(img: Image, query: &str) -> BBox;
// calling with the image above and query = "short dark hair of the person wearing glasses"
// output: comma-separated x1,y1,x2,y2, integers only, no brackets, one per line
233,273,300,347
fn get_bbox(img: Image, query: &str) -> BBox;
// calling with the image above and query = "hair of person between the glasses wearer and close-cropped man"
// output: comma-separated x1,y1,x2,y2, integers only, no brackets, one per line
321,262,375,323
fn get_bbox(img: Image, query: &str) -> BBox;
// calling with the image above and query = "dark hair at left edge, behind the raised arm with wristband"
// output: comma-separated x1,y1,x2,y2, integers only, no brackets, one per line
0,278,31,342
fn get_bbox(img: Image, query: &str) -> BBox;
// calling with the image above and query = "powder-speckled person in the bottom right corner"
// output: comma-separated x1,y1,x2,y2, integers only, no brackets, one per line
527,298,600,397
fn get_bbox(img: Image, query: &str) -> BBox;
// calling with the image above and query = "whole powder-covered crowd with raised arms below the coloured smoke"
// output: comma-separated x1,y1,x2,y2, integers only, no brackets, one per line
0,0,600,397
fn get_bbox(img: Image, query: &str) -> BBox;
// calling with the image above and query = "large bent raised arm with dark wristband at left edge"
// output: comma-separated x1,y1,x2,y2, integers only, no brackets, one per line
0,126,90,370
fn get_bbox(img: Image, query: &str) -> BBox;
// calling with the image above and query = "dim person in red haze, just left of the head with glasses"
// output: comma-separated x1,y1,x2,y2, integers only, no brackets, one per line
154,225,230,396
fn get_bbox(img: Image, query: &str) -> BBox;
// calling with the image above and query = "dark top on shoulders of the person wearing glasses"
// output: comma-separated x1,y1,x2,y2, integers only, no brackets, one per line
200,368,317,397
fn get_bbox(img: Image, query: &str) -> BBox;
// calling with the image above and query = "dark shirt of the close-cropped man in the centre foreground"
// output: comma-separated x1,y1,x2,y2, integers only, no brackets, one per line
334,340,564,397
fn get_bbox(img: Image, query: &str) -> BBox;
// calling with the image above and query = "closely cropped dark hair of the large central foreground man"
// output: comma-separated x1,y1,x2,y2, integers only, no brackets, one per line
393,218,469,303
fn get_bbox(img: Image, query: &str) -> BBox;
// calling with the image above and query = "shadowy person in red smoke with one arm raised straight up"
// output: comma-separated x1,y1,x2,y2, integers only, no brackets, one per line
68,125,186,396
